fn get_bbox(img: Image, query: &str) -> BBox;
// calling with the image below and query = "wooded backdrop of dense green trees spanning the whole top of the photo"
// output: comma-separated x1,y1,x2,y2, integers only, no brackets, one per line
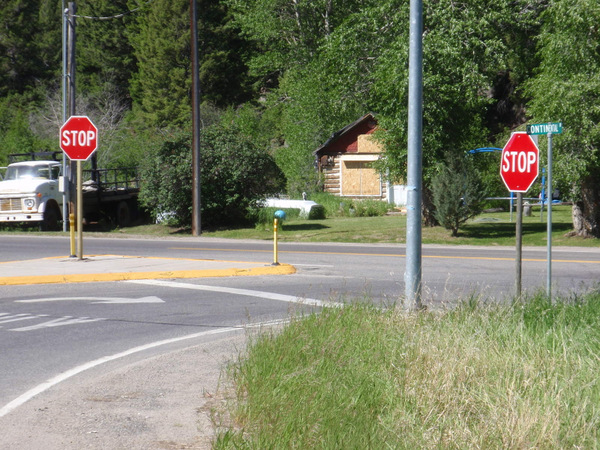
0,0,600,236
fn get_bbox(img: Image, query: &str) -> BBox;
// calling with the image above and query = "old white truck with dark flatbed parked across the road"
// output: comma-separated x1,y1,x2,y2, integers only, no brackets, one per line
0,153,139,230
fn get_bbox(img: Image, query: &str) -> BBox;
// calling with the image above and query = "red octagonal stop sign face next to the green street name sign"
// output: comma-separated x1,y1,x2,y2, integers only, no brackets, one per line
500,131,540,192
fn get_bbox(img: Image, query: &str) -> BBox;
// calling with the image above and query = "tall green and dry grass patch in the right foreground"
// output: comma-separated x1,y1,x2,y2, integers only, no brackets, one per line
215,294,600,449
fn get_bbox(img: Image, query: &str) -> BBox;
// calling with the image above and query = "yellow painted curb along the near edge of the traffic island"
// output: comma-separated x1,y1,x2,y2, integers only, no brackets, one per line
0,264,296,286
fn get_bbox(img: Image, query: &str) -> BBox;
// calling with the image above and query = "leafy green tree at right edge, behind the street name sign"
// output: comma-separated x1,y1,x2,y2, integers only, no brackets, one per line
526,0,600,237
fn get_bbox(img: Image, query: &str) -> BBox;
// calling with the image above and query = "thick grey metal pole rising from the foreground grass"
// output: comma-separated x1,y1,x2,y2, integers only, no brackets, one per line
404,0,423,311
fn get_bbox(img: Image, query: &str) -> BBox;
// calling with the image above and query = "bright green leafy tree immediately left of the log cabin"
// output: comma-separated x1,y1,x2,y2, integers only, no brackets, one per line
272,7,382,195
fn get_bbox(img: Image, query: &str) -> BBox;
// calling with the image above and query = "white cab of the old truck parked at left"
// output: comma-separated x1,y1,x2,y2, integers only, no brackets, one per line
0,161,62,230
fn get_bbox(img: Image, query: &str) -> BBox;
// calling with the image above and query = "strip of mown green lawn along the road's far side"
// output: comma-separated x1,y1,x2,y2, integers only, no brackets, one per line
4,206,600,247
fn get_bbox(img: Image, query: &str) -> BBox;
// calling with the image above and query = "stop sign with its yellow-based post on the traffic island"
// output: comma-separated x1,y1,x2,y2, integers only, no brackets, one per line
60,116,98,260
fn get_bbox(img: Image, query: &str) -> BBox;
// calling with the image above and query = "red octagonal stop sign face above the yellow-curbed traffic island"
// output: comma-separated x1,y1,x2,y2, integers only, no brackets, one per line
60,116,98,161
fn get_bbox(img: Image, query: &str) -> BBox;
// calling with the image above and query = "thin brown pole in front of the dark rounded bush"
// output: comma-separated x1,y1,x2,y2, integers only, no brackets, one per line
190,0,202,236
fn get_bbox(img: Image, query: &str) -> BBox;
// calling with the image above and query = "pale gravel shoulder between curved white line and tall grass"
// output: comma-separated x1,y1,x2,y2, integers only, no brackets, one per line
0,333,247,450
